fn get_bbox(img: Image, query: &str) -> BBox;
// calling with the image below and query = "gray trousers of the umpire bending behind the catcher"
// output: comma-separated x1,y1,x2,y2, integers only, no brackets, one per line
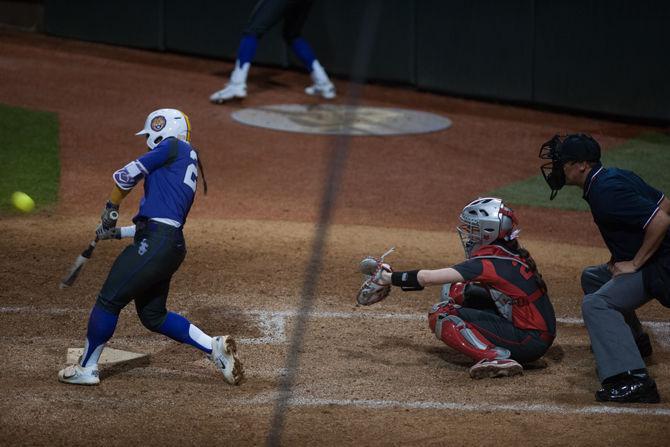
582,264,650,382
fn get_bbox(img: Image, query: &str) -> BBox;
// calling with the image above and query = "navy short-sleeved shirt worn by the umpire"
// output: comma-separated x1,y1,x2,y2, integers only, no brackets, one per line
584,164,670,262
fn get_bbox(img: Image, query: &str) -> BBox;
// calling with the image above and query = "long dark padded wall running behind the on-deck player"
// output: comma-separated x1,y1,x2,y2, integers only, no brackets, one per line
44,0,670,122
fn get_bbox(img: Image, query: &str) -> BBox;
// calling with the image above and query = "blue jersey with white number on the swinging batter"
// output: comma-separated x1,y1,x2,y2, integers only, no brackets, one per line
114,138,198,226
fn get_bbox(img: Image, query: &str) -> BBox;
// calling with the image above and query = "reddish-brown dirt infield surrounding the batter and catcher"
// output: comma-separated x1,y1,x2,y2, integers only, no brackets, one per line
0,31,670,447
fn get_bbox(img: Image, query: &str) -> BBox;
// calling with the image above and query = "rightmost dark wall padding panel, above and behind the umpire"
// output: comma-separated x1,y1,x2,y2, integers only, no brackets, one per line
533,0,670,120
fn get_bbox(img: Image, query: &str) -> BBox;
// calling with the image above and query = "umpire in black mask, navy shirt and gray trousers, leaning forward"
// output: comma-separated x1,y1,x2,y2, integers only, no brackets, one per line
540,134,670,403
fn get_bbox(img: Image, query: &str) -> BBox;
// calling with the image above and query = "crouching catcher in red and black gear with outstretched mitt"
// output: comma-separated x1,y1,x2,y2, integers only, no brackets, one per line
357,197,556,379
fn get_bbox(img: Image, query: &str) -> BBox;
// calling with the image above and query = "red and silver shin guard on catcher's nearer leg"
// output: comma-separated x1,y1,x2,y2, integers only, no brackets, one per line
435,314,511,361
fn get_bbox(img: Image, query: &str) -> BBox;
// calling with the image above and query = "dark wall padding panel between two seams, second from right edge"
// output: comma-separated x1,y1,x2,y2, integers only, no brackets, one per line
416,0,533,102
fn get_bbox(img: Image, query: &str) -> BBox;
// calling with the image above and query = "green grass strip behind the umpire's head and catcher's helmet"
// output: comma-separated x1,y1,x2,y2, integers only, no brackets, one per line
487,133,670,211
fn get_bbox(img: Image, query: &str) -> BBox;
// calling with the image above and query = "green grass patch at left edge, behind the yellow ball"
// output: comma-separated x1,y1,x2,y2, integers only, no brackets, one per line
0,104,60,211
